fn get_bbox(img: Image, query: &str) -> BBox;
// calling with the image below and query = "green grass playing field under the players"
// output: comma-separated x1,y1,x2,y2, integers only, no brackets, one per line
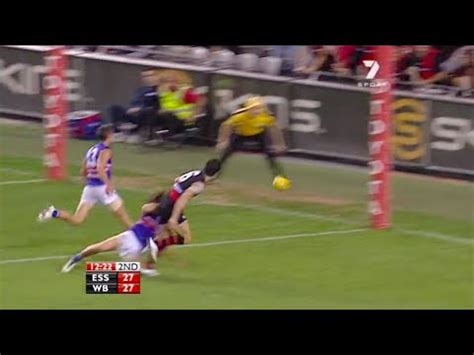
0,123,474,309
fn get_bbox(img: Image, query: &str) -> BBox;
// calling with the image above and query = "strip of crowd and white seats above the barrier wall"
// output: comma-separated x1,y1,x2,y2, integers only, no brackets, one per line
69,45,474,97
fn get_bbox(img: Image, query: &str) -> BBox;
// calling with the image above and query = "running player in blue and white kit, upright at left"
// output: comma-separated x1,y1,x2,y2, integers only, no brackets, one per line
38,125,132,227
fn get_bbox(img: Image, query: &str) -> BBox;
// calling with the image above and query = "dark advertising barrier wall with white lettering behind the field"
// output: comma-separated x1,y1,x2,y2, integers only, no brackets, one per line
0,46,474,176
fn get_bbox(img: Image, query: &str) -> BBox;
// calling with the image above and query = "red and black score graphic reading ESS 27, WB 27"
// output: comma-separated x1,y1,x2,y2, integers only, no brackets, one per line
86,261,140,294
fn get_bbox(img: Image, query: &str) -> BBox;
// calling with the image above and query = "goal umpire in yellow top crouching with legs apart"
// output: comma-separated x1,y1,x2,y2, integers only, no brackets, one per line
216,96,289,187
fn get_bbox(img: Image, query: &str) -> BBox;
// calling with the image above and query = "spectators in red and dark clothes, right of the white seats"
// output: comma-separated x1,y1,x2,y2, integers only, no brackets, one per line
284,45,474,89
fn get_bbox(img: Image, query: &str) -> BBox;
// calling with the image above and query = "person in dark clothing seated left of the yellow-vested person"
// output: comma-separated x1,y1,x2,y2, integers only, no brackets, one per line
107,68,160,143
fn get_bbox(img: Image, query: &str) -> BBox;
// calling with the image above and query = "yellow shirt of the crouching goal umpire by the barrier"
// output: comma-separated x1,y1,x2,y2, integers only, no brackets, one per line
224,108,275,137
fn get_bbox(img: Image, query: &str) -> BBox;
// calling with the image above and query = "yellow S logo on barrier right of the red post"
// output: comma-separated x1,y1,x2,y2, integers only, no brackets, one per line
392,98,426,160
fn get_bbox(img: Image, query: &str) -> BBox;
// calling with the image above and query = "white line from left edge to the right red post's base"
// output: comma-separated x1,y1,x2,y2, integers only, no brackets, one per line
0,228,368,265
